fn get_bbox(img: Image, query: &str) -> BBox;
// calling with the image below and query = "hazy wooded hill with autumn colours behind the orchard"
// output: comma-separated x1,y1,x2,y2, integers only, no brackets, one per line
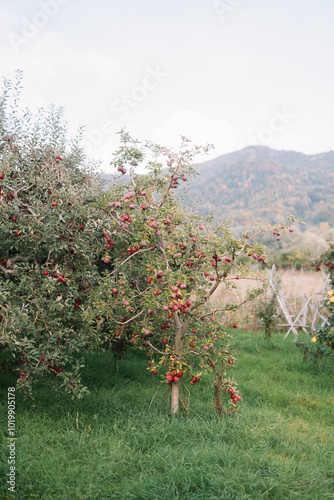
187,146,334,227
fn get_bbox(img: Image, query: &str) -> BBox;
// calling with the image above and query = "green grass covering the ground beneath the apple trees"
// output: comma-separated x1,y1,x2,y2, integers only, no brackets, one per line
0,331,334,500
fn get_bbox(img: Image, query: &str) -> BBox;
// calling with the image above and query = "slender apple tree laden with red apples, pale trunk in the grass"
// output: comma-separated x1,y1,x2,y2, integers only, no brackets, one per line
86,131,294,414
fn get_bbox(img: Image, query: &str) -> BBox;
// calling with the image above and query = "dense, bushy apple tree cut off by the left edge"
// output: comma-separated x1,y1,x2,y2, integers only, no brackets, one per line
0,73,118,395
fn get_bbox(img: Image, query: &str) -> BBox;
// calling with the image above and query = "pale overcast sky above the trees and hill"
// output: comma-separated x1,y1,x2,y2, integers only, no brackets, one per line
0,0,334,171
